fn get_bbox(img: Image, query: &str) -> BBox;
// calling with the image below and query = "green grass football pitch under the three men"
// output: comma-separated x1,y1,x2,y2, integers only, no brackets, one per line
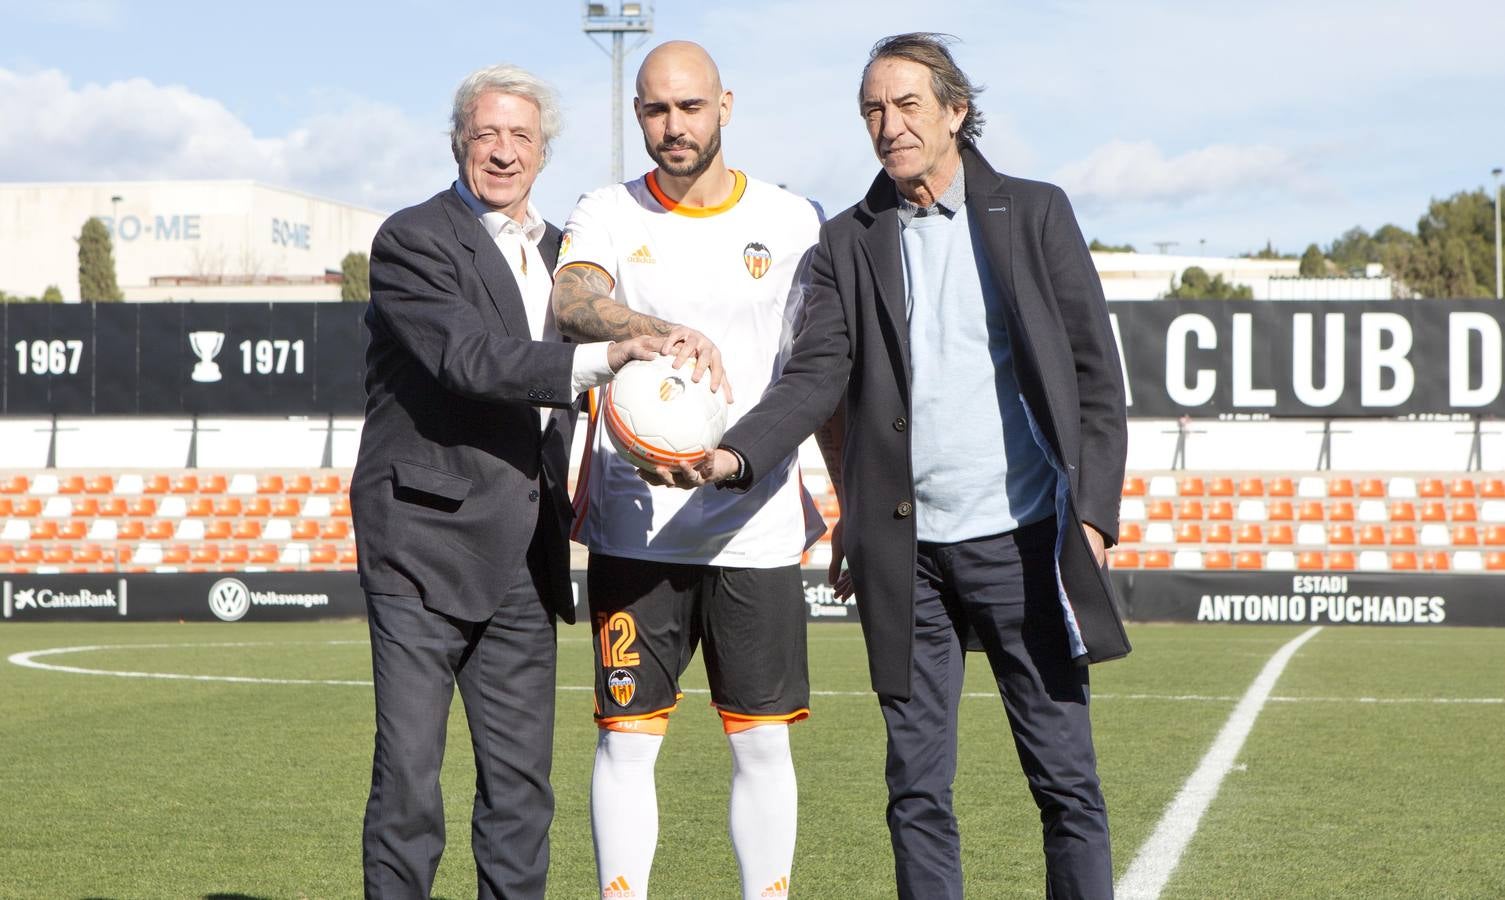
0,622,1505,900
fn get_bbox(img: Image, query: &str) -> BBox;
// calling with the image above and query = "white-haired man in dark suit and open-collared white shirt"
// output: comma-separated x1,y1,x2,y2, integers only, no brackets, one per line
351,65,662,897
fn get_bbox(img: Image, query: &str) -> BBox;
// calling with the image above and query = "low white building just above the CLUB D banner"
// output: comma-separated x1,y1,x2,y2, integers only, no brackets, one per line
1093,251,1394,299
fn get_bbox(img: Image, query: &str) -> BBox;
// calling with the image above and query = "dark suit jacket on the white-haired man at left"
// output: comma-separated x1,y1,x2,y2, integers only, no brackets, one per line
351,188,575,622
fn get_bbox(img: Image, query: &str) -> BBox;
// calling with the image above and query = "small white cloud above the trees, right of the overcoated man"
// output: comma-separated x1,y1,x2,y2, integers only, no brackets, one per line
1054,140,1309,208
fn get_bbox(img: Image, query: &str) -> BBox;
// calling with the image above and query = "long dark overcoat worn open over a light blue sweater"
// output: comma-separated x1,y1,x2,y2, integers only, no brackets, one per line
722,146,1129,698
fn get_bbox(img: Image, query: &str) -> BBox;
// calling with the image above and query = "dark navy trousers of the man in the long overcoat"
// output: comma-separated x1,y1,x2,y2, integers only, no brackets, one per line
880,519,1114,900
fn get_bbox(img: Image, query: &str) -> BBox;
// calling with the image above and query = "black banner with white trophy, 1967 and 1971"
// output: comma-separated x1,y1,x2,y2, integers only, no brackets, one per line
0,303,366,415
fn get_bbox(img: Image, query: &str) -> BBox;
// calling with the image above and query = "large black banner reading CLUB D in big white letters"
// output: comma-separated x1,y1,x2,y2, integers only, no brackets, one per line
1108,299,1505,418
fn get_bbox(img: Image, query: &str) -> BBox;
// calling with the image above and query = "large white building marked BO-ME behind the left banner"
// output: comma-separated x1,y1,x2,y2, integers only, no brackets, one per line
0,181,387,301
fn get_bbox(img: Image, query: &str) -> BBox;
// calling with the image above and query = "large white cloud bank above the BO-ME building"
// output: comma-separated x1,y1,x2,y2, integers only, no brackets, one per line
0,69,453,209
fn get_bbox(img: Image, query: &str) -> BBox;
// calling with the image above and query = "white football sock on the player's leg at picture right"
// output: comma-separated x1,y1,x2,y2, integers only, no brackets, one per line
727,722,799,900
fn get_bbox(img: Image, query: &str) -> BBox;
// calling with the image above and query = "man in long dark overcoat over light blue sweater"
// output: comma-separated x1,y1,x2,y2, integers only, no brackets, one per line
698,35,1129,900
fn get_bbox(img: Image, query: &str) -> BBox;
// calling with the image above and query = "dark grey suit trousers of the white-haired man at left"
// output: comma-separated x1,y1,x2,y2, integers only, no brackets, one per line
363,538,555,898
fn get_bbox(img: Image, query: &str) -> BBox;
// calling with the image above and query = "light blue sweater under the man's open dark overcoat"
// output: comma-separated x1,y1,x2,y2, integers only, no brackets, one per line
900,194,1055,543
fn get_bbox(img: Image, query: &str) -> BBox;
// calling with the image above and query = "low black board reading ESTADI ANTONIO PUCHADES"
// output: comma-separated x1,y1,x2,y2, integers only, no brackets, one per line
1114,572,1505,626
